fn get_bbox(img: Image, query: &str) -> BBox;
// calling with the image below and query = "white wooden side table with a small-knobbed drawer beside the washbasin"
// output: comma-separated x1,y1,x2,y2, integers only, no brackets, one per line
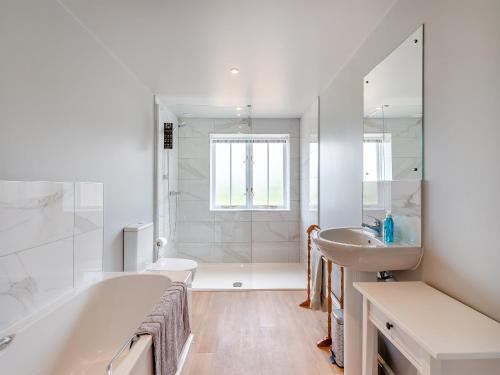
354,282,500,375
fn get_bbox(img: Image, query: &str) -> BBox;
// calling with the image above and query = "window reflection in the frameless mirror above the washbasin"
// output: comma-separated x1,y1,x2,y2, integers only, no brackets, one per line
363,133,392,209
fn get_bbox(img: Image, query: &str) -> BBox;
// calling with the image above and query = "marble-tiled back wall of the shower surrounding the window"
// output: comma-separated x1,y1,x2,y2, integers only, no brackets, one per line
167,118,300,263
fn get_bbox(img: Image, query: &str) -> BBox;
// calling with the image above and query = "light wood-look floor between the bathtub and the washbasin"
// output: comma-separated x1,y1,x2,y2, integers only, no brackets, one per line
183,291,343,375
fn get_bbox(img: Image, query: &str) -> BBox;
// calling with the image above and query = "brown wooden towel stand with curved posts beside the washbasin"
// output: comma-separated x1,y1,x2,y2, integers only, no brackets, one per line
299,224,344,348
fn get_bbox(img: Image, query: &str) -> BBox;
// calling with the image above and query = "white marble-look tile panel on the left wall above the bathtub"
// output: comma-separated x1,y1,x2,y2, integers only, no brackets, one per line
0,180,103,330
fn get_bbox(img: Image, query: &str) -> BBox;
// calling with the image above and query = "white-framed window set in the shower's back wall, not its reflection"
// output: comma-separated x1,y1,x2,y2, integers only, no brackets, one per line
210,134,290,210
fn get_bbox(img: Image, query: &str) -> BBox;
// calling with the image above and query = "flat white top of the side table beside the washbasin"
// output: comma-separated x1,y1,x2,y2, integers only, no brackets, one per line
354,282,500,359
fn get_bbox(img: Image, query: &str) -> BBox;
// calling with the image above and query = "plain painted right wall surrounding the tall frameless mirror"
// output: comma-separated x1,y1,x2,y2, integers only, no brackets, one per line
320,0,500,374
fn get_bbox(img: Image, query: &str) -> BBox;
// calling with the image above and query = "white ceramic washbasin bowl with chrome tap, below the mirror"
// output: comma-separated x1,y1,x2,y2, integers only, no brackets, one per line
313,228,422,272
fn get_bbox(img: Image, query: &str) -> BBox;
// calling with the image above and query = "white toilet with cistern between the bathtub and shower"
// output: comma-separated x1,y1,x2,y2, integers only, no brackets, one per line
123,223,198,283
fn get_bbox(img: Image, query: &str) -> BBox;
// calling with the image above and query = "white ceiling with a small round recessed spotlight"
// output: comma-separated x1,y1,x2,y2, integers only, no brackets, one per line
63,0,395,117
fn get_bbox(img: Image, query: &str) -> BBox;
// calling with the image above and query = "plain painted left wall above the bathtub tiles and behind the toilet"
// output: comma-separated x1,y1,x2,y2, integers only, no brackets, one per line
0,0,154,270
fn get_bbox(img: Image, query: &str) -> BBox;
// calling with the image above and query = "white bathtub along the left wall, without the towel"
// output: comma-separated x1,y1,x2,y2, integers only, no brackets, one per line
0,274,183,375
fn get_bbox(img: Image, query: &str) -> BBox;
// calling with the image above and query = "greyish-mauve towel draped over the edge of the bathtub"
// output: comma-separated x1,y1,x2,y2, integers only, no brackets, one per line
136,282,191,375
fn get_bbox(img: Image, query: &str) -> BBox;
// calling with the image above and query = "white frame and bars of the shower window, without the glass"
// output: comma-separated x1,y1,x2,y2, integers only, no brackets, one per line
209,133,290,211
